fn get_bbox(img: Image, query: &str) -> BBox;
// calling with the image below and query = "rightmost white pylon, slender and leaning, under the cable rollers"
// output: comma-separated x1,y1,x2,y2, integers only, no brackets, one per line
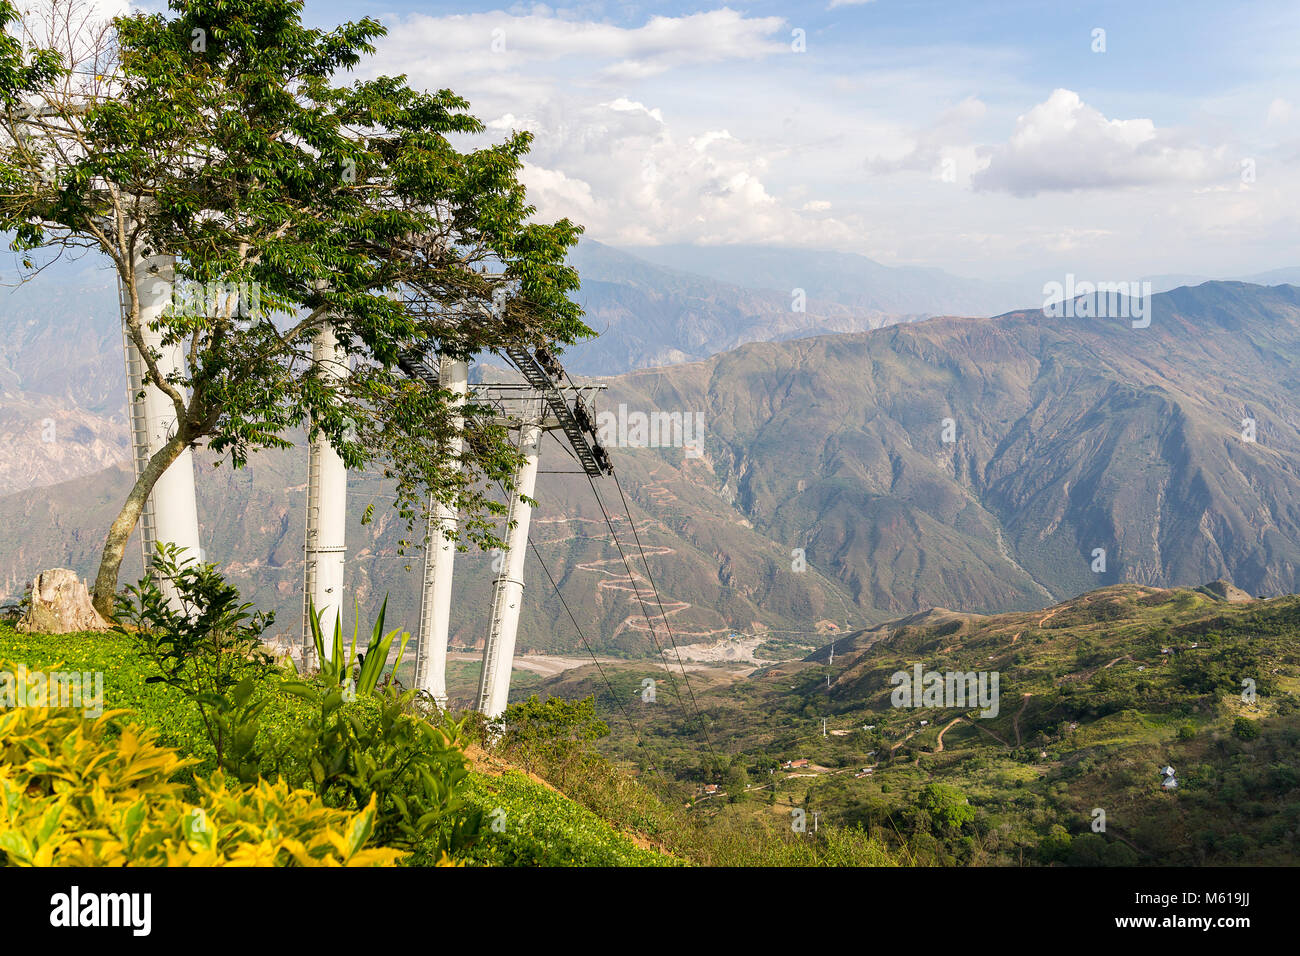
477,399,543,718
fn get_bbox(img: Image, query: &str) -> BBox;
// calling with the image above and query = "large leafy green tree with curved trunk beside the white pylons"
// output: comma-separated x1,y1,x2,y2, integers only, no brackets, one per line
0,0,590,614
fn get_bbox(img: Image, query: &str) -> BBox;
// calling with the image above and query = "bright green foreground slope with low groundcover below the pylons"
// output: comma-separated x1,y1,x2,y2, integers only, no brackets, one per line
0,623,906,866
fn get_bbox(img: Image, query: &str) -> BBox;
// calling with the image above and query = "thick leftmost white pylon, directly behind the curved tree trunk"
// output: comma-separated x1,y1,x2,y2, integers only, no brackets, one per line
118,250,204,609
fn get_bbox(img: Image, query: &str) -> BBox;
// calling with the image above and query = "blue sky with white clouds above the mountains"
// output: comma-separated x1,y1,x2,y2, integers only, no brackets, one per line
188,0,1300,280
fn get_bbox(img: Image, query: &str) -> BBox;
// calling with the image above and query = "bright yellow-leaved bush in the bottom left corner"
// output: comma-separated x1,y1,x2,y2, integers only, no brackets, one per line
0,662,402,866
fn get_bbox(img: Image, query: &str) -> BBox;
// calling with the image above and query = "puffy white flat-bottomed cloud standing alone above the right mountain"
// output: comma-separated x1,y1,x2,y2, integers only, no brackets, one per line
971,90,1238,196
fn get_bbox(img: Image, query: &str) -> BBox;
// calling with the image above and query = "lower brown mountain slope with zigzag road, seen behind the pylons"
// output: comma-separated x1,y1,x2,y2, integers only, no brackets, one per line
0,445,861,657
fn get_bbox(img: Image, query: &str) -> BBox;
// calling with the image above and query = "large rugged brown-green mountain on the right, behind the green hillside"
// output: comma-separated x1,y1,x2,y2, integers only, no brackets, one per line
600,282,1300,613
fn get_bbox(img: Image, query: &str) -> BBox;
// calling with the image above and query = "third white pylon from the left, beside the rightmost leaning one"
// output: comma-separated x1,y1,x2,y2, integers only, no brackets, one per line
415,358,469,710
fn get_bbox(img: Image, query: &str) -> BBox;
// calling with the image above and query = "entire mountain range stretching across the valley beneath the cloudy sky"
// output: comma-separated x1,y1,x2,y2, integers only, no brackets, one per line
0,243,1300,657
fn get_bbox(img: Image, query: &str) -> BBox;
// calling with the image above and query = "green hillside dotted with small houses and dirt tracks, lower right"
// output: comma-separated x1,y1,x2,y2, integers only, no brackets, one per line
533,584,1300,865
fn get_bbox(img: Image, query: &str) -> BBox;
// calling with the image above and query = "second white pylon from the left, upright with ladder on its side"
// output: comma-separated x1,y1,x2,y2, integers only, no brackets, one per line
303,323,348,662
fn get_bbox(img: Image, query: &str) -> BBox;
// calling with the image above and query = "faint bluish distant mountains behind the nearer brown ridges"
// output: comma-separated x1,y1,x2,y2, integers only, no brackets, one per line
0,241,920,494
